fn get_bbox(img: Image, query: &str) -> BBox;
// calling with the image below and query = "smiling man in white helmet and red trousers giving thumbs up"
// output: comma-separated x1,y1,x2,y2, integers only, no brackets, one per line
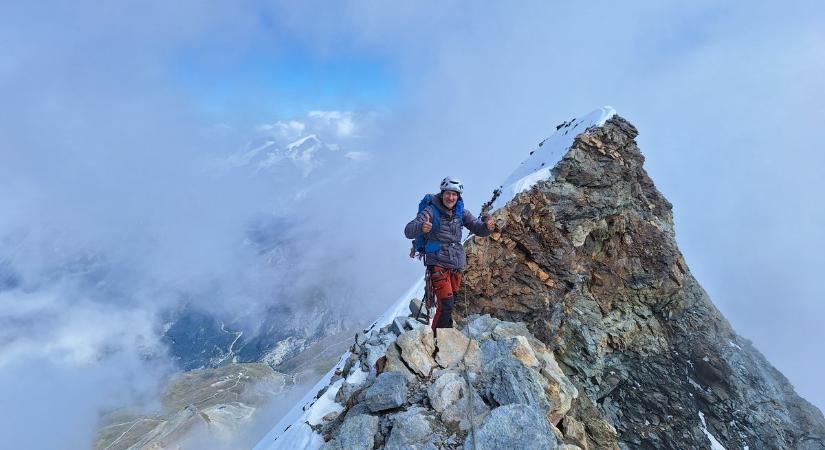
404,177,493,331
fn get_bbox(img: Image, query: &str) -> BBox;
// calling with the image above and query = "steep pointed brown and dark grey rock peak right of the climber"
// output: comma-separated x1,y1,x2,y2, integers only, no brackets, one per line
455,116,825,449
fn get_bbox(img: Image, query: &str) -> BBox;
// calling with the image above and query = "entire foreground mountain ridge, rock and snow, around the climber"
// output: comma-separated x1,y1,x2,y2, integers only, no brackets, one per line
256,107,825,450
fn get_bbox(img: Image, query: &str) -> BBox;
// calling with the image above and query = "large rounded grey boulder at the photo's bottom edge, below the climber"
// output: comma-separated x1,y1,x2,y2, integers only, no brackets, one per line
464,403,559,450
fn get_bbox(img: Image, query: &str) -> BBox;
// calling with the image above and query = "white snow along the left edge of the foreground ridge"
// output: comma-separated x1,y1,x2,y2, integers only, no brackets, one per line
254,106,616,450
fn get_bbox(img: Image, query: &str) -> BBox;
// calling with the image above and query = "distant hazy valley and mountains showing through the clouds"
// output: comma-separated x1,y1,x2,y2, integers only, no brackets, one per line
90,122,369,450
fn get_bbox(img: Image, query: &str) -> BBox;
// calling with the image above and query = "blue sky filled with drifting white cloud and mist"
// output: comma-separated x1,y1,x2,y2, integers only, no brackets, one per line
0,0,825,448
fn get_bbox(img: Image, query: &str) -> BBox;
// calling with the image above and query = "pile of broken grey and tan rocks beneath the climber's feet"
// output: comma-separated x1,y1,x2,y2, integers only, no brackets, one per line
311,306,584,450
